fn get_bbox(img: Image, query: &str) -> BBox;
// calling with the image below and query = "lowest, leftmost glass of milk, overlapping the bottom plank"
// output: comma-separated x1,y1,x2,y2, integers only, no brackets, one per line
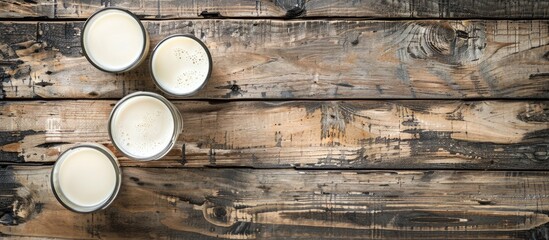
51,143,122,213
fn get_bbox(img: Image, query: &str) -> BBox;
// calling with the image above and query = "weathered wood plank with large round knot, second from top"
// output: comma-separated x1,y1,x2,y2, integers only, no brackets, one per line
0,20,549,99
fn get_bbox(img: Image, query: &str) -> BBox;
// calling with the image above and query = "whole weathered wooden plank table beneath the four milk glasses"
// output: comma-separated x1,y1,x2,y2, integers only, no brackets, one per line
0,0,549,239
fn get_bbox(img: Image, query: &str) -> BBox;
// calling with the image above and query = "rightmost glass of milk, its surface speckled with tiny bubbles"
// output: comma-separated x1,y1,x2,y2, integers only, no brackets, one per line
150,34,212,96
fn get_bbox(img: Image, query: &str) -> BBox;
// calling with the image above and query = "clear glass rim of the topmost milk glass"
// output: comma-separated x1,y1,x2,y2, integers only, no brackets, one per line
80,7,149,73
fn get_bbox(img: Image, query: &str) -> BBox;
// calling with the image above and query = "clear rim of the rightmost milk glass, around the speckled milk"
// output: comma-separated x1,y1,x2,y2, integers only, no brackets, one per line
149,33,213,97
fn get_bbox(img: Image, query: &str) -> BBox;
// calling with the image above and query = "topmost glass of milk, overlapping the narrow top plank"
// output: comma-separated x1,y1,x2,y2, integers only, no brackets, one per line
80,7,149,73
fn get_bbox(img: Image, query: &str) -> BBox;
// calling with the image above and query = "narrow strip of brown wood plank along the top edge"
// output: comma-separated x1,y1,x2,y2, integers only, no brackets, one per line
0,0,549,19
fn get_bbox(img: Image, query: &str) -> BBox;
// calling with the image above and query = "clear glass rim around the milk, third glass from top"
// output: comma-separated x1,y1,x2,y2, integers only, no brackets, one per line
108,91,183,161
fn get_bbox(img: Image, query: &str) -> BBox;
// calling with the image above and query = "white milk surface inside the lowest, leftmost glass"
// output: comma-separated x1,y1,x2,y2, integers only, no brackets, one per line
57,147,116,207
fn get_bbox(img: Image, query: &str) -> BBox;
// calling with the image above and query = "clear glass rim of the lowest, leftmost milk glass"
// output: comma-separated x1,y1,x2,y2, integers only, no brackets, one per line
50,143,122,213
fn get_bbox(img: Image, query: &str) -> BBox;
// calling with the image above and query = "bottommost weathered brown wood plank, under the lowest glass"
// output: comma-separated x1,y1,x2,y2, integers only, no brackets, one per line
0,167,549,239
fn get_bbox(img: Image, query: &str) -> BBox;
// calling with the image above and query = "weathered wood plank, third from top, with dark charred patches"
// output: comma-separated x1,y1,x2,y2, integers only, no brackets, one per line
0,101,549,170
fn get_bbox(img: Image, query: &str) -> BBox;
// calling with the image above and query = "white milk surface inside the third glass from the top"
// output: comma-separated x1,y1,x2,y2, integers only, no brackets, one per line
111,96,175,158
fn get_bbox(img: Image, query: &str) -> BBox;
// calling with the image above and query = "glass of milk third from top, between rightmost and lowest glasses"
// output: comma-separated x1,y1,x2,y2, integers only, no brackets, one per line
108,92,183,161
